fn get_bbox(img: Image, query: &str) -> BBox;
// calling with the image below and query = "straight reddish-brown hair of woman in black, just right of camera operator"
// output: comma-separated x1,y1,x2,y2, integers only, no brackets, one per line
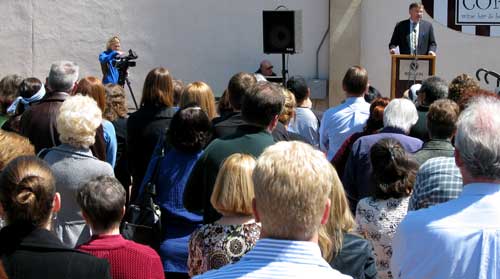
141,67,174,107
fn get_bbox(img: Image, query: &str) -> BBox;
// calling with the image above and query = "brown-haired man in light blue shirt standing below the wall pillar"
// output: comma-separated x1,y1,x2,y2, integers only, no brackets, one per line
319,66,370,161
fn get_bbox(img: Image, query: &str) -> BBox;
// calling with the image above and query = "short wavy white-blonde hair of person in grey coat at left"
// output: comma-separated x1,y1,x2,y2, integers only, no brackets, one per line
56,95,102,148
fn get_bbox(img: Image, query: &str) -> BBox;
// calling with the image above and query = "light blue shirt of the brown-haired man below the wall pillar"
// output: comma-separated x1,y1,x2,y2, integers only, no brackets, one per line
319,97,370,161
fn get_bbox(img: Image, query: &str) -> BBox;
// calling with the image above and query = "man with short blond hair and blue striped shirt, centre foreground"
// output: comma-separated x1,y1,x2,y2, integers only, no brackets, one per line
195,141,351,278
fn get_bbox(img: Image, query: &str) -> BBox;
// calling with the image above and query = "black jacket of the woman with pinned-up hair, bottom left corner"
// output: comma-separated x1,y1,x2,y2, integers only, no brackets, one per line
0,225,111,279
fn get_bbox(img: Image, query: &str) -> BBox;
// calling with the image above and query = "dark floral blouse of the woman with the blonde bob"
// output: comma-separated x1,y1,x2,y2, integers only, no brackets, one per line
188,222,260,277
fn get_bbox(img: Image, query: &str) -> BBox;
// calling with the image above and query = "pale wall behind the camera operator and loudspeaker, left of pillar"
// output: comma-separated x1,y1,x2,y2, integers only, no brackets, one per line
0,0,329,104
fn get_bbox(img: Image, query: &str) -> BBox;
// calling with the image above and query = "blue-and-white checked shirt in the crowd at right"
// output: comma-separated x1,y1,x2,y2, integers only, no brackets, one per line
408,157,463,210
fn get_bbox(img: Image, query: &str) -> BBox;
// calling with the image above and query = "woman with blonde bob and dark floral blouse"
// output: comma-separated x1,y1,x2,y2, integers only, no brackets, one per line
188,153,260,276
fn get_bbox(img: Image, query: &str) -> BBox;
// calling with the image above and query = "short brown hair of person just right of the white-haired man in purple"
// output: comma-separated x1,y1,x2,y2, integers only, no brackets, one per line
427,99,460,139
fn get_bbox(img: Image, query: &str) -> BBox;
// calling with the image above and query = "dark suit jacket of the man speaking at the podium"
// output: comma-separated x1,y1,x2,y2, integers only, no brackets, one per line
389,19,437,55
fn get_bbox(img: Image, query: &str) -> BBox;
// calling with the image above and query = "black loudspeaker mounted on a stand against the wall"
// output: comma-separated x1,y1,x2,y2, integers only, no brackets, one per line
262,10,302,53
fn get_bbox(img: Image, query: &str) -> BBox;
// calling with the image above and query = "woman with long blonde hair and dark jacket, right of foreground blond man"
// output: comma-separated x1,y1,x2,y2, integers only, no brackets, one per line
319,166,377,279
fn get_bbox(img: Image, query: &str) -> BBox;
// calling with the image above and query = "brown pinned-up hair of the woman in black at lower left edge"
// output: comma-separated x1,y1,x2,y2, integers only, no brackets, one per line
0,156,56,227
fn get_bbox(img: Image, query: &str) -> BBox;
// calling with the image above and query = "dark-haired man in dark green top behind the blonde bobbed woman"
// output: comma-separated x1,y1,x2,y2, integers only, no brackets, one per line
183,82,285,224
